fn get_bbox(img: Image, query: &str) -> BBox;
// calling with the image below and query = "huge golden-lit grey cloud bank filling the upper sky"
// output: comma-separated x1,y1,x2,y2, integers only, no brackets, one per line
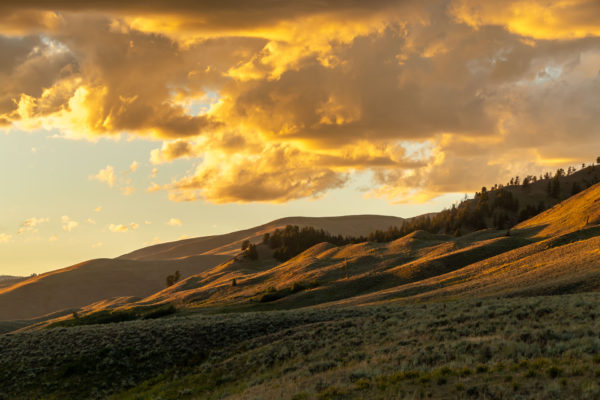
0,0,600,203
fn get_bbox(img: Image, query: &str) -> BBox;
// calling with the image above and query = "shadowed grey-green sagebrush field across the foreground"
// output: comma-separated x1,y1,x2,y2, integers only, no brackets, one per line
0,293,600,399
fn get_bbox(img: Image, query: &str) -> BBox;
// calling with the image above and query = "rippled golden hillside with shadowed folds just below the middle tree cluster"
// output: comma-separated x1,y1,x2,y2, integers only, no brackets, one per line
141,231,528,308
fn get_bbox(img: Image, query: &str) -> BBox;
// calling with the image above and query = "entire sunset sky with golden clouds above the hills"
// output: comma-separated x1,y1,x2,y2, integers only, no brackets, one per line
0,0,600,275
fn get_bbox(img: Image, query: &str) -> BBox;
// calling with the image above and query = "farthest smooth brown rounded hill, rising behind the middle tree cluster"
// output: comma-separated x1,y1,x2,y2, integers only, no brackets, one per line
119,215,404,260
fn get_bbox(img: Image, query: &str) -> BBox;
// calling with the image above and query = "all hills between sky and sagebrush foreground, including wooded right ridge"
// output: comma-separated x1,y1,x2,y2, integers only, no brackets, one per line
0,167,600,321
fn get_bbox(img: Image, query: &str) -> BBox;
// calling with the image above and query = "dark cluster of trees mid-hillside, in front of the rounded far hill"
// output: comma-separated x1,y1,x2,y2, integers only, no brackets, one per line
263,225,366,261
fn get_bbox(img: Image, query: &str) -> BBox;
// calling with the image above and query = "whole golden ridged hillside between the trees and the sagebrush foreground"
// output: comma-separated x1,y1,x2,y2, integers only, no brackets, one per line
136,185,600,308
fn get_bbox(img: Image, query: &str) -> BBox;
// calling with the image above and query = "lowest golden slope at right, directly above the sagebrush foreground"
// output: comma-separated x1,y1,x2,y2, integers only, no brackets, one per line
338,226,600,305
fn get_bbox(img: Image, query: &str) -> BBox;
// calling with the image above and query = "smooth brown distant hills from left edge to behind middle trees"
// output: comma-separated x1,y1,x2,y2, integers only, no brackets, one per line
0,215,403,321
